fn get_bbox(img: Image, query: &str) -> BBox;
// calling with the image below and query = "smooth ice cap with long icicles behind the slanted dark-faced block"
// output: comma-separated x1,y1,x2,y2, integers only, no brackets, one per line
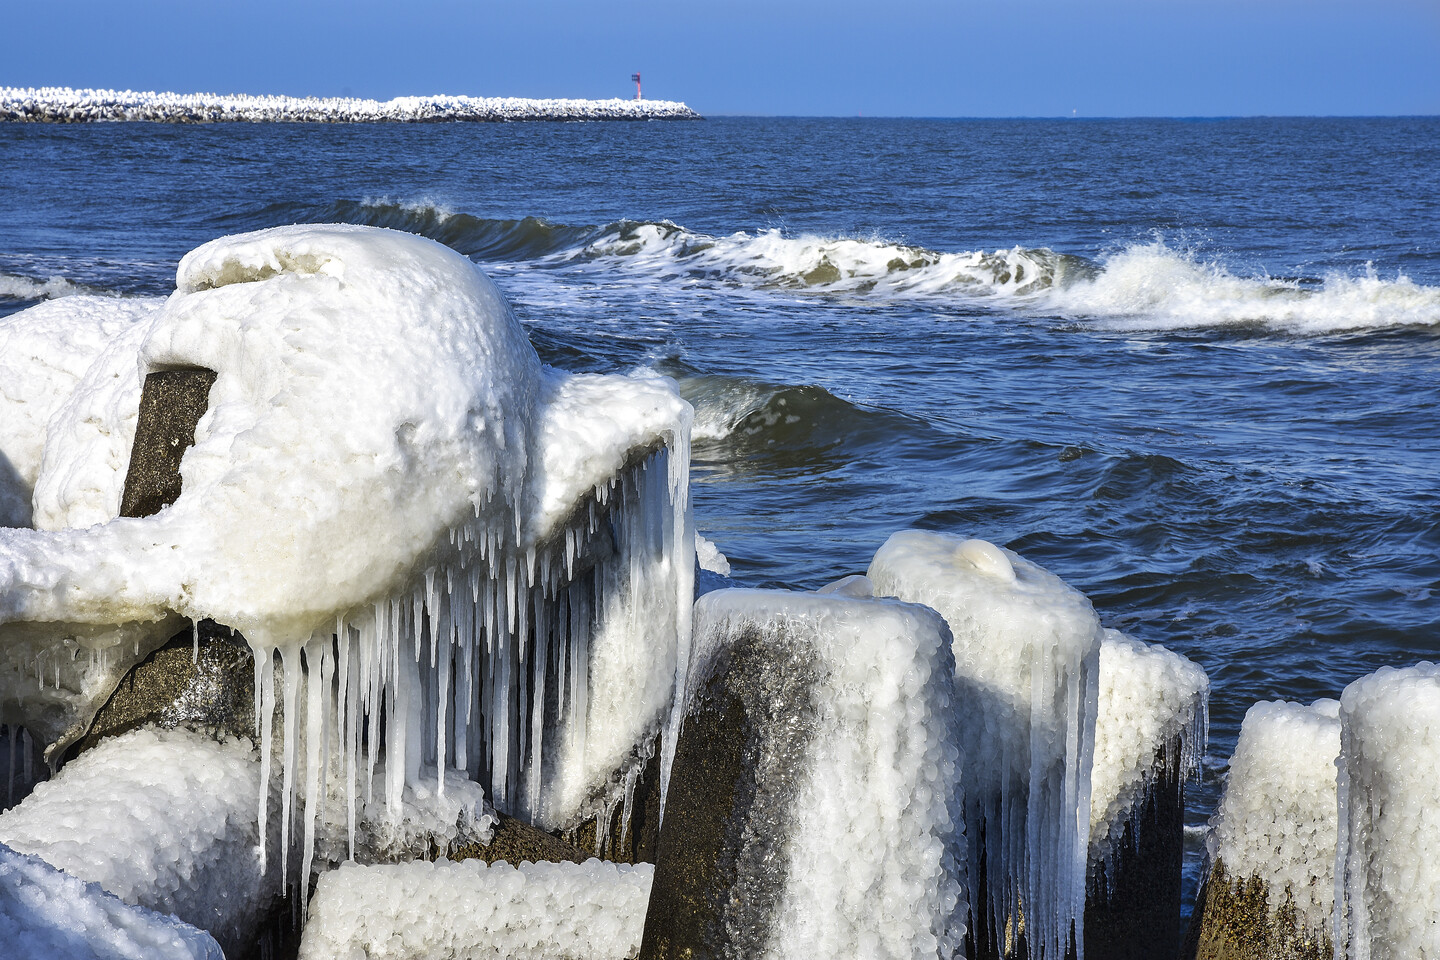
868,530,1100,960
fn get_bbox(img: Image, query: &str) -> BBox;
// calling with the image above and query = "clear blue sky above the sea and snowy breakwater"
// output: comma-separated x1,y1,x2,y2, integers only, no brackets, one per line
11,0,1440,117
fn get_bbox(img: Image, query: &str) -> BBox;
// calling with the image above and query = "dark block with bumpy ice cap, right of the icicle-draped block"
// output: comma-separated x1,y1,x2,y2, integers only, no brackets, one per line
1084,629,1210,960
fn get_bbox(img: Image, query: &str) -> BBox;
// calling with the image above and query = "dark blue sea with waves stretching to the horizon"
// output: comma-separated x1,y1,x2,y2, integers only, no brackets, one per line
0,119,1440,921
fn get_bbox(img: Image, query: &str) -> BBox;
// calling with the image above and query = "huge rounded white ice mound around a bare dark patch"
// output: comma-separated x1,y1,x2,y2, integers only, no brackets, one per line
0,225,541,645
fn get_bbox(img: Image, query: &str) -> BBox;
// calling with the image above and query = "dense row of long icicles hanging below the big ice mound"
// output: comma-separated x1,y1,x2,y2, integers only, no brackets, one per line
252,448,690,878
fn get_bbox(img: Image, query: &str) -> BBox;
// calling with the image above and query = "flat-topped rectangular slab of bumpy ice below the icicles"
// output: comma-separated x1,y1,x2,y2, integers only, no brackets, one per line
300,859,655,960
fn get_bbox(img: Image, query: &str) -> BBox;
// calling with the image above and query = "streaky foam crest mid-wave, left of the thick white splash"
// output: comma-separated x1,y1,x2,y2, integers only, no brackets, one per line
559,220,1083,296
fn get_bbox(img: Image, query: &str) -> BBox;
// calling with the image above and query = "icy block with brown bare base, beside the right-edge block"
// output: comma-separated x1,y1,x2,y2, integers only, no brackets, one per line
1189,699,1341,960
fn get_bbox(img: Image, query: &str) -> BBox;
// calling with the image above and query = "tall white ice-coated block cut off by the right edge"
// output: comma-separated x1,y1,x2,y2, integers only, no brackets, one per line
1335,664,1440,960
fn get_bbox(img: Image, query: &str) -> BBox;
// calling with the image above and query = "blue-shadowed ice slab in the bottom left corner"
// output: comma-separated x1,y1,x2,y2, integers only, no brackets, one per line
0,843,223,960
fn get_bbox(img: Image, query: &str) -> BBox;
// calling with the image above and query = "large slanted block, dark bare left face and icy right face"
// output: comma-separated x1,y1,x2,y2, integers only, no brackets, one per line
641,590,966,960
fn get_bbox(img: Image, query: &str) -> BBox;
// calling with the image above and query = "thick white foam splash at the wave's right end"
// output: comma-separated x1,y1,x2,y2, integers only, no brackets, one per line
1044,242,1440,334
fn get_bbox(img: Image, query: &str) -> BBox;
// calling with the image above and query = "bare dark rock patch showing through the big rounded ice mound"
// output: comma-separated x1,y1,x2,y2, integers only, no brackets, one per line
120,370,216,517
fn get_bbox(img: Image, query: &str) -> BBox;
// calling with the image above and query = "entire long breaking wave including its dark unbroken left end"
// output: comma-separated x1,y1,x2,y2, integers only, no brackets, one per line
230,200,1440,334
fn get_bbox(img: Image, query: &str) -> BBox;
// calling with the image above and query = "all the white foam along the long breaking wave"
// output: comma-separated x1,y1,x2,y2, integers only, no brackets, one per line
527,222,1440,334
